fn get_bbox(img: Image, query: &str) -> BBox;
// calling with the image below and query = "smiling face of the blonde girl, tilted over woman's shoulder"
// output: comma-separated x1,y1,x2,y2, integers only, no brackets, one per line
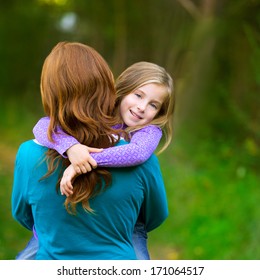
120,83,168,127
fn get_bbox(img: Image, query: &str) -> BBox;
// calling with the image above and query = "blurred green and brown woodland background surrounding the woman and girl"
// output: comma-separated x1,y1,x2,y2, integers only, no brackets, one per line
0,0,260,260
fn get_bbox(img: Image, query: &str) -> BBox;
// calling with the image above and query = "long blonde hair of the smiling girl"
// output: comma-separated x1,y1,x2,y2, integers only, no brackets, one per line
116,61,175,154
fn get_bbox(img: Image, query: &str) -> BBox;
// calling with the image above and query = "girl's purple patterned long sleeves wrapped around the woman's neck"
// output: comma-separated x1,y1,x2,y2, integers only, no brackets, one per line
33,117,162,167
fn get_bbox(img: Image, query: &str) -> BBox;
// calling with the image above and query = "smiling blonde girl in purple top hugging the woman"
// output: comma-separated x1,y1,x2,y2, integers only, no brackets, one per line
17,62,175,259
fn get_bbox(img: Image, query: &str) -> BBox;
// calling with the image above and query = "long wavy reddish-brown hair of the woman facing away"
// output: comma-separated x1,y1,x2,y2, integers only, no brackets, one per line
40,42,119,213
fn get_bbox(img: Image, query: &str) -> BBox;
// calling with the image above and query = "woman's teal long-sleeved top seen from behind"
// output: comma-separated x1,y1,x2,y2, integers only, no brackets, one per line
13,140,168,260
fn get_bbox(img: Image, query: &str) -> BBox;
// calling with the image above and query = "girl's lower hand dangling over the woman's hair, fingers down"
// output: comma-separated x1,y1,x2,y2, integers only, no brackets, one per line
60,164,79,197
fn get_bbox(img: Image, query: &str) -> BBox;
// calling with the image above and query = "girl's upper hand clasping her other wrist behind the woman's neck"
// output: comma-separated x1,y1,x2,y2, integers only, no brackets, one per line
67,144,103,174
